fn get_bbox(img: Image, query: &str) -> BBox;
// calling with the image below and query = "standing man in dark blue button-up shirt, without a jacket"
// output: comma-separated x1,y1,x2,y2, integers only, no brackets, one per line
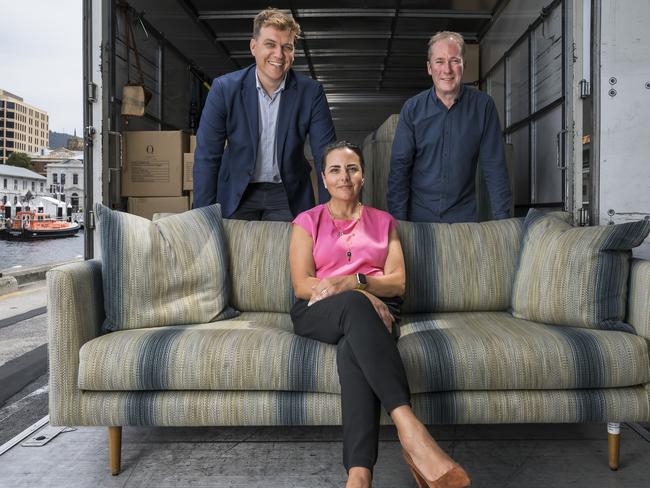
388,32,512,223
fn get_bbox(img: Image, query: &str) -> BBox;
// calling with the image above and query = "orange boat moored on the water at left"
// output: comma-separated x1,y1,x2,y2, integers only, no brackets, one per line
0,210,81,240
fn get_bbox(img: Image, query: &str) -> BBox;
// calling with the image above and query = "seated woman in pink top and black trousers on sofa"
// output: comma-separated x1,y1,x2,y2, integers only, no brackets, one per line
289,141,470,488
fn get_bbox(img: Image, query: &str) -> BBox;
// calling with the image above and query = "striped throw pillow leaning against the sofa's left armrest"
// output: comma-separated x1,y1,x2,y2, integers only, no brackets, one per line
95,204,234,331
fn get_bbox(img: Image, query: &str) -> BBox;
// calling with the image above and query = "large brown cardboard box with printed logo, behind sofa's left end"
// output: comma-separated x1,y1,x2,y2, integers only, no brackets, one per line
122,131,189,197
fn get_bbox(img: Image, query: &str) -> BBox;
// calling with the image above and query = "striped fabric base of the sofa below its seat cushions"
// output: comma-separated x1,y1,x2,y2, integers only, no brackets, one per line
60,386,650,426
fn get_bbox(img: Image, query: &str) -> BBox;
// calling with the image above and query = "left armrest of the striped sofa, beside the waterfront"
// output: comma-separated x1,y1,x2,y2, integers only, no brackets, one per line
47,260,104,425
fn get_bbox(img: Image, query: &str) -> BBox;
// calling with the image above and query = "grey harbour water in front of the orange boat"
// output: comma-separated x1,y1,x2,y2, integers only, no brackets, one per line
0,230,84,270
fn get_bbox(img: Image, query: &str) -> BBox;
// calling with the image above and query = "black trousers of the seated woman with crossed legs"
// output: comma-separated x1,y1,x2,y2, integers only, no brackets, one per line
291,291,410,471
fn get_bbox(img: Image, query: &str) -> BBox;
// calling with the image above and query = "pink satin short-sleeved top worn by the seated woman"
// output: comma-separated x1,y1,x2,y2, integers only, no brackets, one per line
293,204,396,279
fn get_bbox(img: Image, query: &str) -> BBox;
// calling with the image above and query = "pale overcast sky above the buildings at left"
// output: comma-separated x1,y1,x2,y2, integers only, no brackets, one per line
0,0,83,135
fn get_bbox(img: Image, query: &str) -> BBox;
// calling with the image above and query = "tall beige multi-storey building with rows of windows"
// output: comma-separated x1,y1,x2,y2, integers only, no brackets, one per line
0,89,49,163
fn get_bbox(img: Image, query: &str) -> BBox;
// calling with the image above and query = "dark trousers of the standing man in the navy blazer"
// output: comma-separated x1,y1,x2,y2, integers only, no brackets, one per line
229,183,293,222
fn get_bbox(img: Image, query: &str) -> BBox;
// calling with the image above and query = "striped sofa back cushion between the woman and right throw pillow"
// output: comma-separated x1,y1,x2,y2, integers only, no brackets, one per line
398,219,523,313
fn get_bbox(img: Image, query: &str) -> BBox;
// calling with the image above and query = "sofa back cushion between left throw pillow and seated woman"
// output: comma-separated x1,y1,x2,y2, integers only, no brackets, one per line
224,219,295,313
